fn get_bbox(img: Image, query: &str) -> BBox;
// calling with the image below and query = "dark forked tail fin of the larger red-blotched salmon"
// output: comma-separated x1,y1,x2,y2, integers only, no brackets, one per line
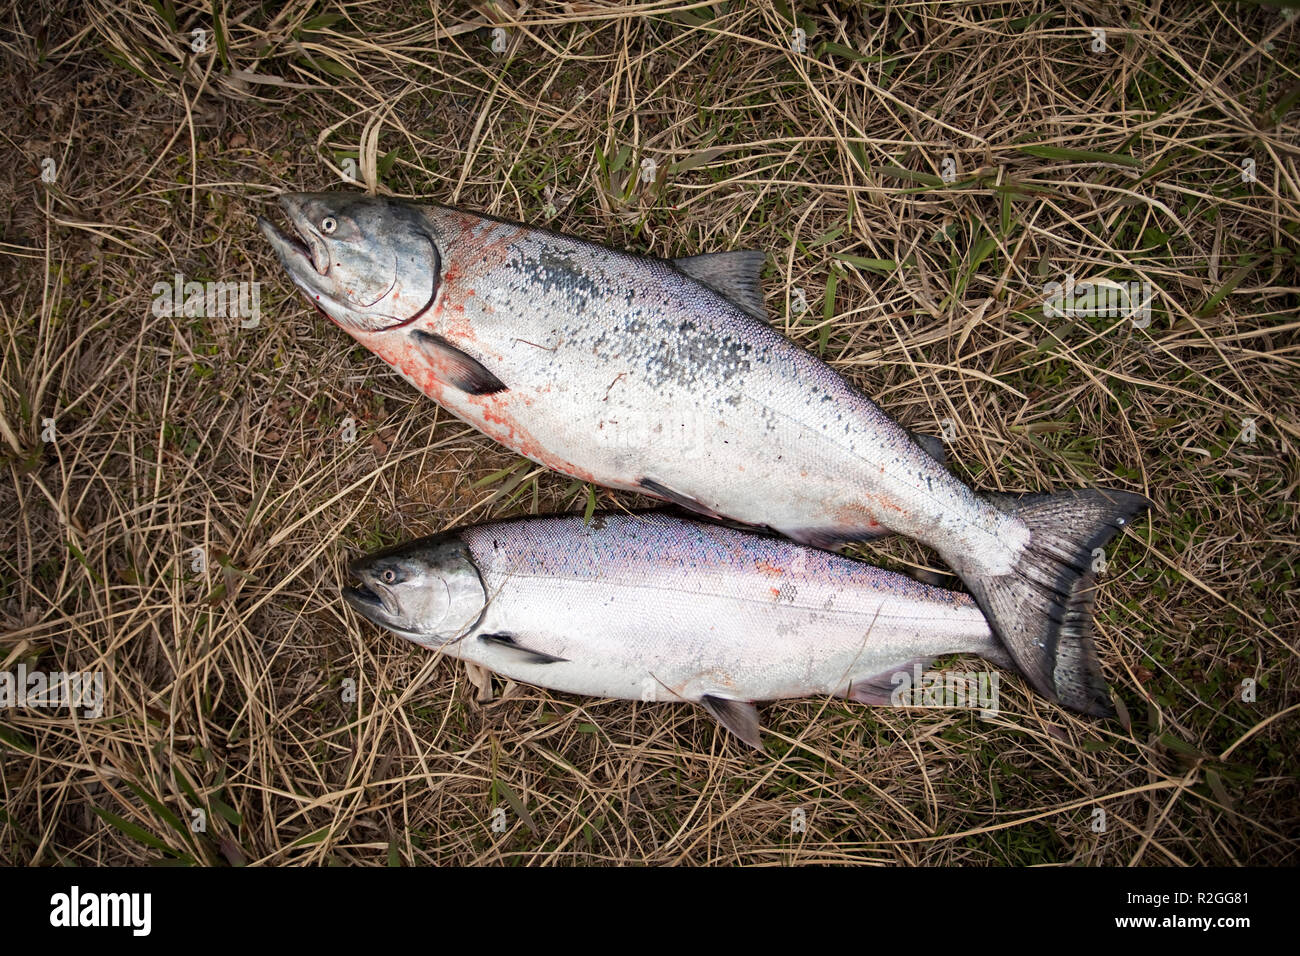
966,489,1151,717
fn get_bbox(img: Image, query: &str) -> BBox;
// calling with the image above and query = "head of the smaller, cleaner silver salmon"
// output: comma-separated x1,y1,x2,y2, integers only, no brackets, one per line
343,535,488,646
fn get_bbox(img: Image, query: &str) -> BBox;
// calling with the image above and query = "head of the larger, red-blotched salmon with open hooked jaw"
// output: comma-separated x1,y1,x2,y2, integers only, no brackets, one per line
257,193,441,333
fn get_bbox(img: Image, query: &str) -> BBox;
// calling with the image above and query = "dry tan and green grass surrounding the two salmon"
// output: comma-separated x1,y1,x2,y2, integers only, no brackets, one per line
0,0,1300,865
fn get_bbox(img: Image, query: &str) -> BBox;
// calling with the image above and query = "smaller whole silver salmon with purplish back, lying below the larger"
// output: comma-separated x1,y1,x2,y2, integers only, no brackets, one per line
343,512,1034,749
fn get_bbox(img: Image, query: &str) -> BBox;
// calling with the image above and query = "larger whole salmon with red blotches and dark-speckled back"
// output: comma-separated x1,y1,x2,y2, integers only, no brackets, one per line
263,194,1149,714
